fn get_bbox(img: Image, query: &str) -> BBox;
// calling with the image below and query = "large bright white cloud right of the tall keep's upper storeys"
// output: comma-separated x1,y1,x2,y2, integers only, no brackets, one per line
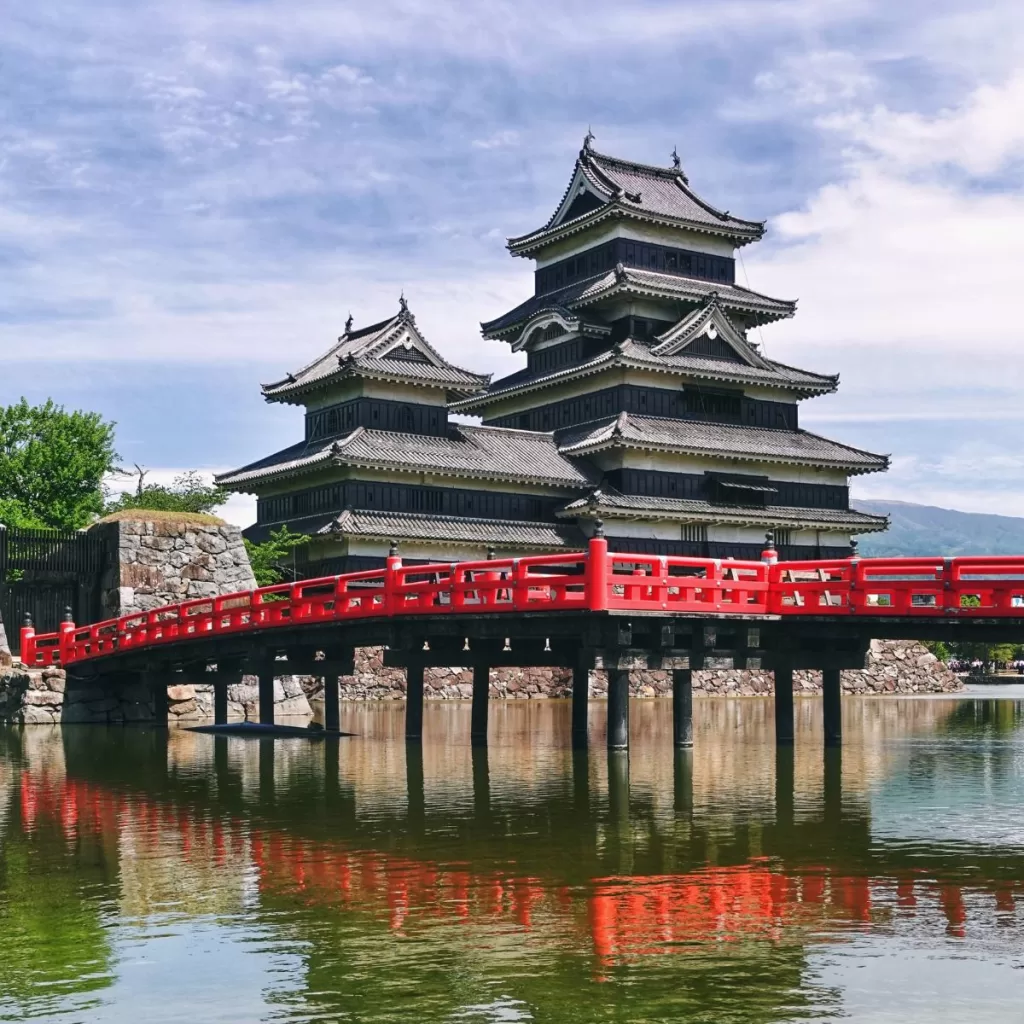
746,68,1024,407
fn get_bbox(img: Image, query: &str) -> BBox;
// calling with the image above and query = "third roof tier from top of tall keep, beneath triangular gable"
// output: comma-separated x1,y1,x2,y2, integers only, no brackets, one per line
450,338,839,413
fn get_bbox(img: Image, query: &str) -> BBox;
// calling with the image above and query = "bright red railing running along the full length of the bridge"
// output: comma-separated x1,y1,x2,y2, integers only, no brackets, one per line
22,538,1024,666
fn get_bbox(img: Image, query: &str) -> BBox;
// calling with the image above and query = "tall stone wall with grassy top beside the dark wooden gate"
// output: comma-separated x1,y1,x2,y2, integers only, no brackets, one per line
92,519,256,618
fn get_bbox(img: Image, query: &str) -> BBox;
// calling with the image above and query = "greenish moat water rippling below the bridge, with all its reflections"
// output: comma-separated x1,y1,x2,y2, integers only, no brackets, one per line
0,696,1024,1024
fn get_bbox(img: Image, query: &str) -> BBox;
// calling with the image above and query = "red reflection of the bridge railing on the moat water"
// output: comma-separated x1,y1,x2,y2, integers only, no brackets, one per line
19,771,1024,962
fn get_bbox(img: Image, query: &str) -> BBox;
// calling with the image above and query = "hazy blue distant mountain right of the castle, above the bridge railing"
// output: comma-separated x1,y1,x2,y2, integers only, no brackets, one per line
853,499,1024,556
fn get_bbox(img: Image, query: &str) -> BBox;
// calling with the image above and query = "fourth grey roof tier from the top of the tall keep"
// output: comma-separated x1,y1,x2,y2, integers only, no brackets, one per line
555,413,889,474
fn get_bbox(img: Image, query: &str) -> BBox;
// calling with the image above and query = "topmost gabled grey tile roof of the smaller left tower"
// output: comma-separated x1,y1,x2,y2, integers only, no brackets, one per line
263,298,490,402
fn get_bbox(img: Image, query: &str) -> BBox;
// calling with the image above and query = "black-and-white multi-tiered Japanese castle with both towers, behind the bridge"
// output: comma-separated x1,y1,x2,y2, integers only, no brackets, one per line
218,134,888,572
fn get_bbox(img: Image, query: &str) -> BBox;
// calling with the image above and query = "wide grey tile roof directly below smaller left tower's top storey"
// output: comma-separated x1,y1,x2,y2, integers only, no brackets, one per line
217,424,594,493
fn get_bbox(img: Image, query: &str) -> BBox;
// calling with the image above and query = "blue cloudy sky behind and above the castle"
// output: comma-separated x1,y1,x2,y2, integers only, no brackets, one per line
0,0,1024,524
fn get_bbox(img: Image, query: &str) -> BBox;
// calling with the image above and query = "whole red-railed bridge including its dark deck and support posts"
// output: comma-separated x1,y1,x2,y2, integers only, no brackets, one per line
22,537,1024,748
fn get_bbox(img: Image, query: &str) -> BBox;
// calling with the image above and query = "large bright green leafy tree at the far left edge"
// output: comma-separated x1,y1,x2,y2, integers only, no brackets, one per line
0,398,117,529
